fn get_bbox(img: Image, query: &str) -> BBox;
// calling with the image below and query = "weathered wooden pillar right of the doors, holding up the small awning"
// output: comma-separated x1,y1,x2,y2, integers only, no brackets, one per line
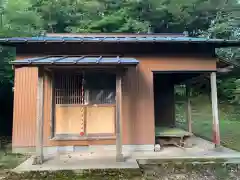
116,72,124,162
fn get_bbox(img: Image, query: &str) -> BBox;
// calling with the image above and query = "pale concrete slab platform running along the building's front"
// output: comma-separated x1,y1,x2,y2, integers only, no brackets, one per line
13,137,240,172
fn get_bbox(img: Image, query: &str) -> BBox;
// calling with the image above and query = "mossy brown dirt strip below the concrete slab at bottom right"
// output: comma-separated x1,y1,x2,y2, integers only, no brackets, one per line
142,163,240,180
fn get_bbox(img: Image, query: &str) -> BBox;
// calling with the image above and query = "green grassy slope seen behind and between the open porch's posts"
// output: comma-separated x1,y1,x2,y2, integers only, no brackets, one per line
176,97,240,151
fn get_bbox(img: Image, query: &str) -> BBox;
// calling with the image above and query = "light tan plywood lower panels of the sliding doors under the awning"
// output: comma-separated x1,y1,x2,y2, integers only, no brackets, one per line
55,105,115,135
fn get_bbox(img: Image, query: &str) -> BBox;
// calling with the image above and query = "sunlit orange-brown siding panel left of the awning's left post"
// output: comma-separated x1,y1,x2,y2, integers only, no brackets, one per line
12,67,38,147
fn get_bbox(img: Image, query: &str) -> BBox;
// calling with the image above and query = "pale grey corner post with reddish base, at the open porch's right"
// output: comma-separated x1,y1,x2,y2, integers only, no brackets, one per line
210,72,220,147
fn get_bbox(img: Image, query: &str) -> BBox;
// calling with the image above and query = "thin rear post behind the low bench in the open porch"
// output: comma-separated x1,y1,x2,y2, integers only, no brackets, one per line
186,84,192,133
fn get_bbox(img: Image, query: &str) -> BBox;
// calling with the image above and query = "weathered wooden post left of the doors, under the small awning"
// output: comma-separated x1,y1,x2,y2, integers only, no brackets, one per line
34,67,44,164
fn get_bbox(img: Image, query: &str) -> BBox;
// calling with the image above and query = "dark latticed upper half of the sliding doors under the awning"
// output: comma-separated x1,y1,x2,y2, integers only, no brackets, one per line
55,73,116,105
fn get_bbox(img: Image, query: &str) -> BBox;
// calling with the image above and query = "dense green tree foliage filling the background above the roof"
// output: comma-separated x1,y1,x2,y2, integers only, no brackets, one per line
1,0,238,36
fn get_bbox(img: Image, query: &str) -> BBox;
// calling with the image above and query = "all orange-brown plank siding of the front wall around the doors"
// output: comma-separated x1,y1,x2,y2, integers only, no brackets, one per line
13,57,216,147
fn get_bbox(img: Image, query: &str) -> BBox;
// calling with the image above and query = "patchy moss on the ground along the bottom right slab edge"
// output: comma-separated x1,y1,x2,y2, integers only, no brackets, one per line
141,162,240,180
